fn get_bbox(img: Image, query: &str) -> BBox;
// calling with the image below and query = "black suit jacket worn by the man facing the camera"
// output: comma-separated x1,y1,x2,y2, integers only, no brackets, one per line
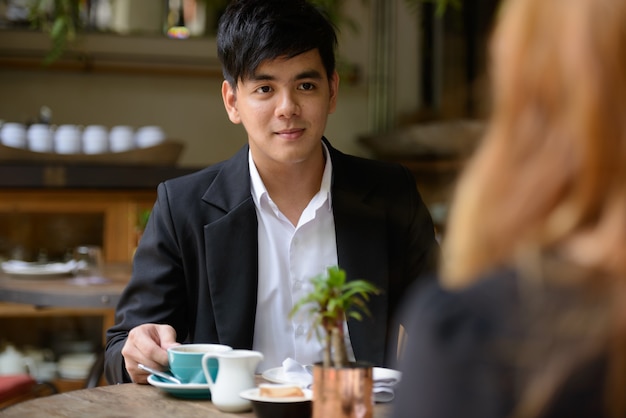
105,139,438,383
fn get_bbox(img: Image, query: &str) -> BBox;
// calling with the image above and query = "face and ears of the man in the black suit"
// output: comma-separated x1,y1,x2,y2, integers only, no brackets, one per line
222,49,339,167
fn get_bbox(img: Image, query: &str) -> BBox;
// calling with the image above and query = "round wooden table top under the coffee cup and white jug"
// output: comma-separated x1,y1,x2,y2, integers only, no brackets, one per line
0,383,391,418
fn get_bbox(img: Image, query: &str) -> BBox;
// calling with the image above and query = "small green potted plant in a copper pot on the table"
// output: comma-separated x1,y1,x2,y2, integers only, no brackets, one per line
291,266,380,418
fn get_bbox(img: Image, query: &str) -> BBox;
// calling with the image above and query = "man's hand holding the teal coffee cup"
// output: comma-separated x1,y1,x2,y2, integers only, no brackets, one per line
122,324,180,384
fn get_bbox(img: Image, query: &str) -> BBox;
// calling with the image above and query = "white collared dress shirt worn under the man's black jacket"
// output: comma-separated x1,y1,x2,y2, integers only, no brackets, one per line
248,144,354,372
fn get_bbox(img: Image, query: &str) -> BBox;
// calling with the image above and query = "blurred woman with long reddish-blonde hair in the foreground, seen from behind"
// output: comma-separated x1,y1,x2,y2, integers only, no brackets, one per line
394,0,626,418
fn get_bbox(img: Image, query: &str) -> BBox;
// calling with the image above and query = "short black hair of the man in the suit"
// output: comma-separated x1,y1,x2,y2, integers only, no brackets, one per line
217,0,337,88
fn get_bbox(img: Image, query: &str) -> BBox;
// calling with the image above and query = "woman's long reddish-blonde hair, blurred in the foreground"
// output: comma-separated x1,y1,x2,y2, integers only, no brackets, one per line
442,0,626,287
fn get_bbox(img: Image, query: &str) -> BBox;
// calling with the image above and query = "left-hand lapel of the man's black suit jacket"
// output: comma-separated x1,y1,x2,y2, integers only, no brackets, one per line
203,146,258,348
